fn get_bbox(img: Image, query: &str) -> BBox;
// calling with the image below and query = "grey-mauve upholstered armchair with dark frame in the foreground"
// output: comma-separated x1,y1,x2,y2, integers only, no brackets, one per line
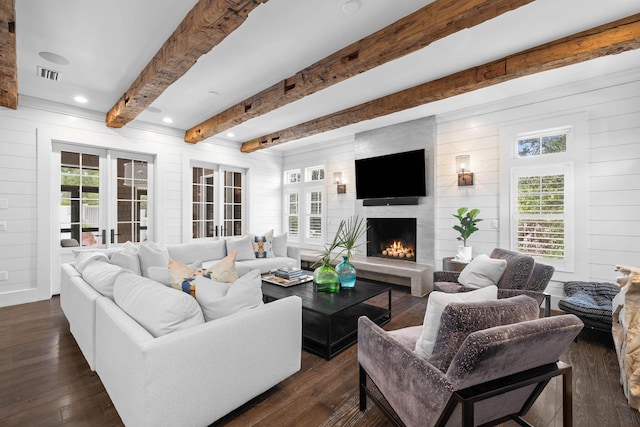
358,295,583,427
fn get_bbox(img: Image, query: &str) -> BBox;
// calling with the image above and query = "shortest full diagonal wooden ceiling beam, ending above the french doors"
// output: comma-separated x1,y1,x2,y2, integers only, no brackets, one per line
106,0,268,128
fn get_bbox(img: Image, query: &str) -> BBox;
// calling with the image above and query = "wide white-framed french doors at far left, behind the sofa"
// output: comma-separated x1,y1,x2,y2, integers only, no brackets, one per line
52,143,154,294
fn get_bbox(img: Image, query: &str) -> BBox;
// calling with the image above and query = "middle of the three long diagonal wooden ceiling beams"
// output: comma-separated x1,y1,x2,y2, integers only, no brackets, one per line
184,0,533,143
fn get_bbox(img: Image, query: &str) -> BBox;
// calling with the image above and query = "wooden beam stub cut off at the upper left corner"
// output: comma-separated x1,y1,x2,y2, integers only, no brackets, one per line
0,0,18,110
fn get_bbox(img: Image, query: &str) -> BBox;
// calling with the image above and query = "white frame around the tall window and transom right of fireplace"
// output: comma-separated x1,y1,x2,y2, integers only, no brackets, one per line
499,113,589,280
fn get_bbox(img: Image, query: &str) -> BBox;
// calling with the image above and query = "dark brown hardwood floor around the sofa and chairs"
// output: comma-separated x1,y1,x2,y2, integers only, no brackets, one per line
0,287,640,427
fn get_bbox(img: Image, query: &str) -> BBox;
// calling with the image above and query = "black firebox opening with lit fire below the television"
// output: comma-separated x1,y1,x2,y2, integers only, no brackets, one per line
367,218,416,262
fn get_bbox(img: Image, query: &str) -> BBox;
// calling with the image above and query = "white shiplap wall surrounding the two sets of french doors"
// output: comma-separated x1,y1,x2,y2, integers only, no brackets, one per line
0,98,282,306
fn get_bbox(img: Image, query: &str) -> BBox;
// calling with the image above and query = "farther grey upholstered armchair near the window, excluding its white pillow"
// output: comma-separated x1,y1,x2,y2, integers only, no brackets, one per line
433,248,555,317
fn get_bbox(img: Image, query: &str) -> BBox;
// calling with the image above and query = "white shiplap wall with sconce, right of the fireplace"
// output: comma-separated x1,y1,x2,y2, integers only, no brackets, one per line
436,70,640,304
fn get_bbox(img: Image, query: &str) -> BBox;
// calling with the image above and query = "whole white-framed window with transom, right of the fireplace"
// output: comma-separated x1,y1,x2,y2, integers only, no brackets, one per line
499,113,589,280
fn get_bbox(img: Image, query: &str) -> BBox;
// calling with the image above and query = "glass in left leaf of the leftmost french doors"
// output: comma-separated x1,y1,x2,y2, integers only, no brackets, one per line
59,151,100,247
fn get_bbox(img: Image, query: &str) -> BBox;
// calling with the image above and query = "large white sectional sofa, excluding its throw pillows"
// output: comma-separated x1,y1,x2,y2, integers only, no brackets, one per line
60,237,302,426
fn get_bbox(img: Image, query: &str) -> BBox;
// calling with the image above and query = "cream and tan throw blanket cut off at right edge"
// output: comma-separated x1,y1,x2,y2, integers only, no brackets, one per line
612,266,640,410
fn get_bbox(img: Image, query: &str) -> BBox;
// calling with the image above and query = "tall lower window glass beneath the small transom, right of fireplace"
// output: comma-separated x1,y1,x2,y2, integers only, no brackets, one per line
514,166,568,261
